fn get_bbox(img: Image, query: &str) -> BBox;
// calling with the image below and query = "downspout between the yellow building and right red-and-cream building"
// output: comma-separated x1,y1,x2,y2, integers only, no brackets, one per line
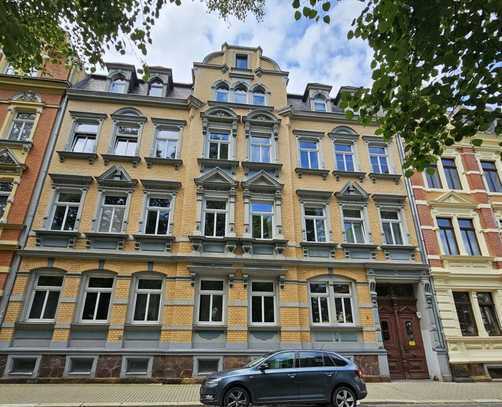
396,136,448,355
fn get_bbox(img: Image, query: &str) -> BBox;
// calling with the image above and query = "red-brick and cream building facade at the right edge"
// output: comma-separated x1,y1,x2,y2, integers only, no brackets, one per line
411,132,502,380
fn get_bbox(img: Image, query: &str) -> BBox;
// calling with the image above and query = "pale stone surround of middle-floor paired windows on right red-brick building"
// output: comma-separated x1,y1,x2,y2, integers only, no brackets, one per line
431,207,490,257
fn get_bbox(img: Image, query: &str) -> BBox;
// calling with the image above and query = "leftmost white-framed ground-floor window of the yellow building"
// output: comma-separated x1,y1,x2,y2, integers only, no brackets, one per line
28,274,63,321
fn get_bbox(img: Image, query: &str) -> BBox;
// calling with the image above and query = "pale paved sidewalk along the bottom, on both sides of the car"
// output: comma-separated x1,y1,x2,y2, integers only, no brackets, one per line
0,381,502,407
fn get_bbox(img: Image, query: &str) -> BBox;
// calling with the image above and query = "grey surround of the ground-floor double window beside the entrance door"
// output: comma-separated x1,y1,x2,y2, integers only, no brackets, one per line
307,276,359,327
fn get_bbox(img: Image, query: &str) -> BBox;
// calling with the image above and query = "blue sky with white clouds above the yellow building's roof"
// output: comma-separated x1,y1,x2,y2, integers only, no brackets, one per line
105,0,372,96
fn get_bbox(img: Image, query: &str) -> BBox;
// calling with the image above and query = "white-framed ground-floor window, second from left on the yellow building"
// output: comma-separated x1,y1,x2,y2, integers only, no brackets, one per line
81,277,113,322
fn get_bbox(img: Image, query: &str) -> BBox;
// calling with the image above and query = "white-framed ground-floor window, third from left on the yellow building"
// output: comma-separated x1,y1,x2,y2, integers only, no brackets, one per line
133,277,162,322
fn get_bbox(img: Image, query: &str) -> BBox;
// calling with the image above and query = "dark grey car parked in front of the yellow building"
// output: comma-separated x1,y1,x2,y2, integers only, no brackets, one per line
200,350,367,407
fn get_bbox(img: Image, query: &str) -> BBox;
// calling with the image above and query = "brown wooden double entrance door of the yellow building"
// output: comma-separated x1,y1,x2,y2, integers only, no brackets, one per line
378,297,429,379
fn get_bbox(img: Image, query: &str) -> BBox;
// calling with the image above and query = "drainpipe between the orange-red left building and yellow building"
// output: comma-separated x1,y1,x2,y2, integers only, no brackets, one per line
0,94,68,326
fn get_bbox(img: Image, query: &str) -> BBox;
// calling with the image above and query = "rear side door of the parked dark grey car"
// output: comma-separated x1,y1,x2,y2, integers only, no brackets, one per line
296,351,334,402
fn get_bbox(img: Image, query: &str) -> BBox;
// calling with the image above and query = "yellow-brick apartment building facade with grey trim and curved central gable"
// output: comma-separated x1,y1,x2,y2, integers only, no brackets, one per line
0,44,448,381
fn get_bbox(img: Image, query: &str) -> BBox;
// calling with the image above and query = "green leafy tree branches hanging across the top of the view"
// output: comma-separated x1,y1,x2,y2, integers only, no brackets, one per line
0,0,502,174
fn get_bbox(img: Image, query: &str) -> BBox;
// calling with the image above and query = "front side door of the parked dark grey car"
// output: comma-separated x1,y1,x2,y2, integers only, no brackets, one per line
249,352,298,403
